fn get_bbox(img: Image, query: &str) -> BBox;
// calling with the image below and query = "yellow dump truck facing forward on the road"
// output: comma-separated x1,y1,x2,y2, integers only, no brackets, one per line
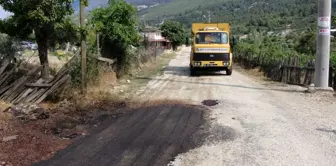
190,23,232,75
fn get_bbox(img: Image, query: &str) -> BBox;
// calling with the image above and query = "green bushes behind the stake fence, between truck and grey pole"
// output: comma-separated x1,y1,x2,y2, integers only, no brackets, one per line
233,30,316,66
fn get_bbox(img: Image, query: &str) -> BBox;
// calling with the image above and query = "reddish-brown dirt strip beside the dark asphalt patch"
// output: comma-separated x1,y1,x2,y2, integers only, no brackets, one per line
0,101,127,166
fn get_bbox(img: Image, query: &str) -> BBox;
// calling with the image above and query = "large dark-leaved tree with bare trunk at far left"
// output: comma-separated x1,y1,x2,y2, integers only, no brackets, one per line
0,0,73,78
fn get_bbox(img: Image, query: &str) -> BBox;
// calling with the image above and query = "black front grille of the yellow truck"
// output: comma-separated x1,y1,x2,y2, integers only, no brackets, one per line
193,53,230,61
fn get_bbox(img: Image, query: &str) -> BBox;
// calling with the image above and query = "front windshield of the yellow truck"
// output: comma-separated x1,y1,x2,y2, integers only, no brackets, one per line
196,32,228,44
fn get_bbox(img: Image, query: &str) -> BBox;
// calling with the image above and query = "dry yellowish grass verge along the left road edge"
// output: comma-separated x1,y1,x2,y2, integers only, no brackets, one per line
58,52,176,108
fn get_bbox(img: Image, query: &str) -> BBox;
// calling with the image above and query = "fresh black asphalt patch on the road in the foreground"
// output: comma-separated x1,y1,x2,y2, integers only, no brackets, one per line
35,104,209,166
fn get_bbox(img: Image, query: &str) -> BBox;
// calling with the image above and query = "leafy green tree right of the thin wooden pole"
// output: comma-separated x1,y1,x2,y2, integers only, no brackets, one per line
90,0,139,74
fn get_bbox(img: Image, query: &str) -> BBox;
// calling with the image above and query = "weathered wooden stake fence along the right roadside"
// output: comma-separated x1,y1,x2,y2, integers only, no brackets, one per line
234,53,336,90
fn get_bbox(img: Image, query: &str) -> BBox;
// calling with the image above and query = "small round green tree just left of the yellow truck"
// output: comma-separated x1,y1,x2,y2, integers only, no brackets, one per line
160,21,186,50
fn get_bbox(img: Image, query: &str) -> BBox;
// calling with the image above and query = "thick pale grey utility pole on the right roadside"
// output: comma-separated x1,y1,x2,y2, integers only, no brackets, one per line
315,0,331,88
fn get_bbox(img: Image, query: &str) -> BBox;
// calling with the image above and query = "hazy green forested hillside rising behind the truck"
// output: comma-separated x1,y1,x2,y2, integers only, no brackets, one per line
140,0,336,34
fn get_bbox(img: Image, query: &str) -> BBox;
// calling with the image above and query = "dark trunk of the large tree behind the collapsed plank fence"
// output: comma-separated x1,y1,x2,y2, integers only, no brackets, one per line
37,39,49,79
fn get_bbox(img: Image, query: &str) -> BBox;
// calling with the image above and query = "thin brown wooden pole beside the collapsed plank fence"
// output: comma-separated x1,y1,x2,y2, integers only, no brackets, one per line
79,0,86,95
